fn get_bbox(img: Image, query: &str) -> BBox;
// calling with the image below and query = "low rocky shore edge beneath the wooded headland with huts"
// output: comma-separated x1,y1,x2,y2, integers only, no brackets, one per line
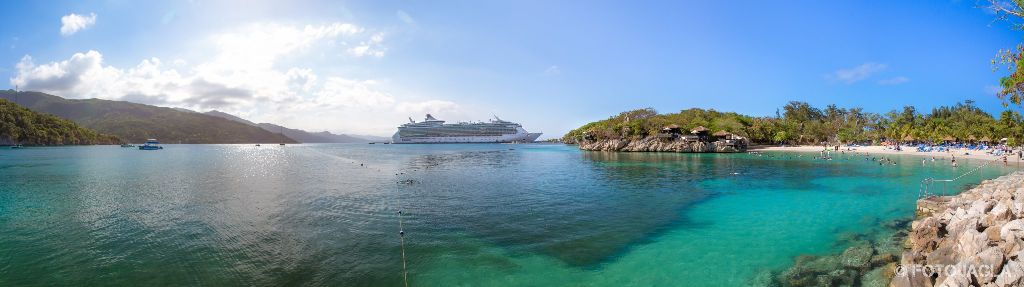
578,136,746,153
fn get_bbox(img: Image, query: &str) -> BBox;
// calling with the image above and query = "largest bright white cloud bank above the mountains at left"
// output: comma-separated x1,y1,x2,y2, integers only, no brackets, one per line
10,23,467,135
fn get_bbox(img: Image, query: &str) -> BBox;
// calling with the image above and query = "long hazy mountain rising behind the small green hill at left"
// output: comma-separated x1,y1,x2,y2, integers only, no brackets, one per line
0,90,296,144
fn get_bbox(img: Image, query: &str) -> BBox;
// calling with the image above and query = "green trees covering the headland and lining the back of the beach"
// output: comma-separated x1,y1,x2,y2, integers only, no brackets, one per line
562,100,1024,146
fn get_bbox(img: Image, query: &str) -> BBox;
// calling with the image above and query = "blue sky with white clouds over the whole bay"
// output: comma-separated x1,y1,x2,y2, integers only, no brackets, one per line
0,0,1024,138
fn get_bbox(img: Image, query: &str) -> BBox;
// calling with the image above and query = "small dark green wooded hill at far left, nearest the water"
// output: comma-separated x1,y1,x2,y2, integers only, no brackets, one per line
0,99,121,146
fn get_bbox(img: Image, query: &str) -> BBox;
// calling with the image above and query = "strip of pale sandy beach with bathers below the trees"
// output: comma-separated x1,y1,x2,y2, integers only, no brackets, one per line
748,146,1021,164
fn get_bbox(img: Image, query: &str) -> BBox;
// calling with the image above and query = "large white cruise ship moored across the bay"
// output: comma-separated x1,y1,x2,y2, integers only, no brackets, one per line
391,114,541,144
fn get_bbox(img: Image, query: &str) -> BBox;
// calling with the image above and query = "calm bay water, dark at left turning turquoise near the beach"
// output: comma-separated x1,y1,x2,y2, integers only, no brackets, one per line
0,145,1015,286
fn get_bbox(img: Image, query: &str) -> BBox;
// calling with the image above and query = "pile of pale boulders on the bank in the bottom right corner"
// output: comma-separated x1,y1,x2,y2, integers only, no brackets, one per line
890,171,1024,287
